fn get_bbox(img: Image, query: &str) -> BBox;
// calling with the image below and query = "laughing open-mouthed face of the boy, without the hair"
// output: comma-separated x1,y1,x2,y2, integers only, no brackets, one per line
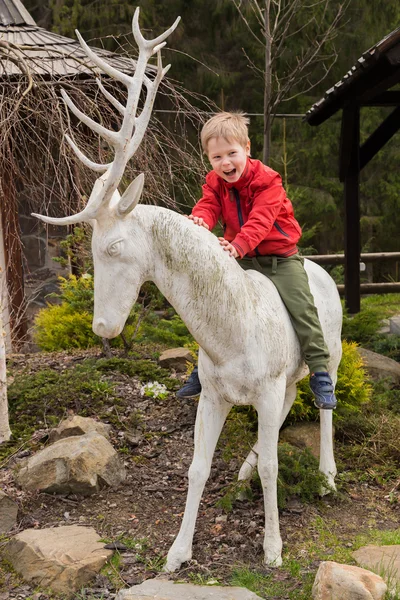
207,137,250,183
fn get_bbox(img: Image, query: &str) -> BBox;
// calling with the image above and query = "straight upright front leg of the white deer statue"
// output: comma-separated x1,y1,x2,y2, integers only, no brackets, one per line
255,381,285,567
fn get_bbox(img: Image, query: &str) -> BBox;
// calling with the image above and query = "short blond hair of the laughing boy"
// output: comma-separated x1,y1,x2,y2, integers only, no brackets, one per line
200,112,250,154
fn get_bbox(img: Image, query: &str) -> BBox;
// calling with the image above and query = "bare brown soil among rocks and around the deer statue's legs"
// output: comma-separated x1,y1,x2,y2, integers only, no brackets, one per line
0,352,400,600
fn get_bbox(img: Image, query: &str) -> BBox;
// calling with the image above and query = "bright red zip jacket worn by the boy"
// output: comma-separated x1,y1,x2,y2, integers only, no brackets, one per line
192,158,301,258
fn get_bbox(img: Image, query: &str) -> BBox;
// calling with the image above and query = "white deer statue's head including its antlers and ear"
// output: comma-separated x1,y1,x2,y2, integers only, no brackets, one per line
33,8,180,338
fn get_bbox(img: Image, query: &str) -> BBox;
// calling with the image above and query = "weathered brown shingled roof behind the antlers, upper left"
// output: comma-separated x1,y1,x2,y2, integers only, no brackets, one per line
0,0,144,79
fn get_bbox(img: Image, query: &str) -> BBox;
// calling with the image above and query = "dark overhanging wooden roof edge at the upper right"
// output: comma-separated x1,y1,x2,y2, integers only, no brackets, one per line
305,27,400,125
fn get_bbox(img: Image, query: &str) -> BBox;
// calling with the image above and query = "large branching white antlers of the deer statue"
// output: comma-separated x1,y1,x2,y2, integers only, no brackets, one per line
33,7,180,225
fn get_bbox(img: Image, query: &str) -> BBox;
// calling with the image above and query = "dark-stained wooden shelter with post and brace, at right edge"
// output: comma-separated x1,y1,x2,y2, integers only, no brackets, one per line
305,28,400,313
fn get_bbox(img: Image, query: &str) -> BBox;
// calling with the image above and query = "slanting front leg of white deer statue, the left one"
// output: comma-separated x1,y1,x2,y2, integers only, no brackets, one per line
164,389,231,572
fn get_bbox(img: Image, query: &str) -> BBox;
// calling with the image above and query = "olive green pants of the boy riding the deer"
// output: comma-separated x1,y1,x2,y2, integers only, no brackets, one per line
238,254,329,373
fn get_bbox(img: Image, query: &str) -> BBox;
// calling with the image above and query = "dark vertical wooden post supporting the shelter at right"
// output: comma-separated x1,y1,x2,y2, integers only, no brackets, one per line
340,105,361,314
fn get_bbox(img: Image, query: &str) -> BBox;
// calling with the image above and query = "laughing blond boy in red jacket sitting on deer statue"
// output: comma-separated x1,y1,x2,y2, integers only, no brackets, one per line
177,112,336,409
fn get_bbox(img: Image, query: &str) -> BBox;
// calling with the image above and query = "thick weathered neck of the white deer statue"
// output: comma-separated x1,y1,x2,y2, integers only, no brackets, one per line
137,206,251,363
